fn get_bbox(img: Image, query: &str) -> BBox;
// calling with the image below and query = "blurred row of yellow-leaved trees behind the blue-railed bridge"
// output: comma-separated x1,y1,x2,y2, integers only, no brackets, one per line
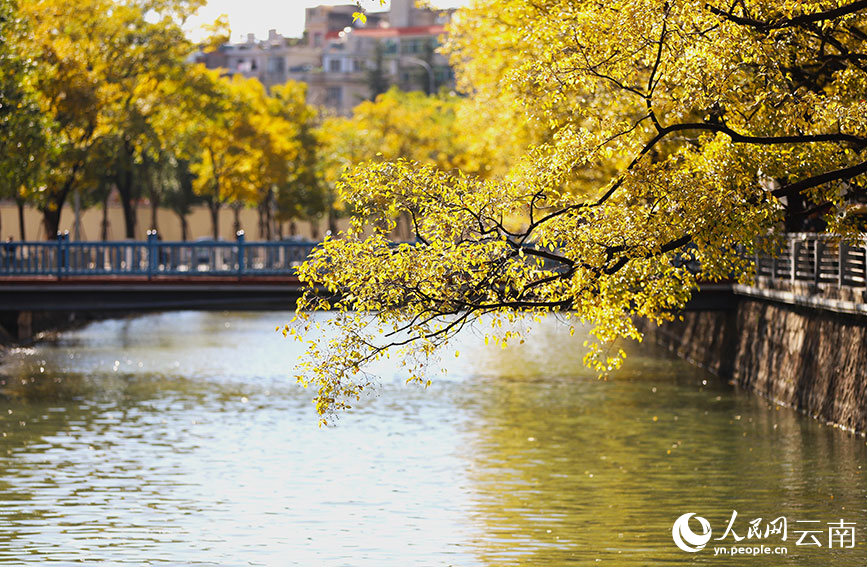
0,0,484,239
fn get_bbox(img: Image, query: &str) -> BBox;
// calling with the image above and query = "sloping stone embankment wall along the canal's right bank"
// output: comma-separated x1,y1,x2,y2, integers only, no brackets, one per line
641,290,867,432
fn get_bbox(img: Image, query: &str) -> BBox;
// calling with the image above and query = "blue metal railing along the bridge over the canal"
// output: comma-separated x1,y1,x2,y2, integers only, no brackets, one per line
0,231,319,278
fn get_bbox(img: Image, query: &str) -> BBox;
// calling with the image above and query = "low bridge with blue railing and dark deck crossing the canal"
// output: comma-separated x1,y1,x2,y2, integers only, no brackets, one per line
0,232,318,312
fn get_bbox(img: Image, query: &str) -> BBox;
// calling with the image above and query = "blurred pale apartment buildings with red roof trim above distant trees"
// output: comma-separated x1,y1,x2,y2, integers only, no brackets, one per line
198,0,454,115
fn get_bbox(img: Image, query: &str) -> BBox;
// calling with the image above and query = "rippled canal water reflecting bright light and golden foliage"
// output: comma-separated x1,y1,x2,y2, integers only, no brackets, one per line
0,312,867,567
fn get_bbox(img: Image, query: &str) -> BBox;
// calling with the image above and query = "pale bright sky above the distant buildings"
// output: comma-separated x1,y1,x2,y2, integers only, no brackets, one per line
186,0,467,41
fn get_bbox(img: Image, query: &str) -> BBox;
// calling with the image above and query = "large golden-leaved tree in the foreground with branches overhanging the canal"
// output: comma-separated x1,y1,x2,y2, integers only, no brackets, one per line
289,0,867,424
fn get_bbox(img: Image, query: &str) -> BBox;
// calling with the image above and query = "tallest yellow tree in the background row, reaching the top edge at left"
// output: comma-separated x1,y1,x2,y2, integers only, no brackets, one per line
20,0,202,237
